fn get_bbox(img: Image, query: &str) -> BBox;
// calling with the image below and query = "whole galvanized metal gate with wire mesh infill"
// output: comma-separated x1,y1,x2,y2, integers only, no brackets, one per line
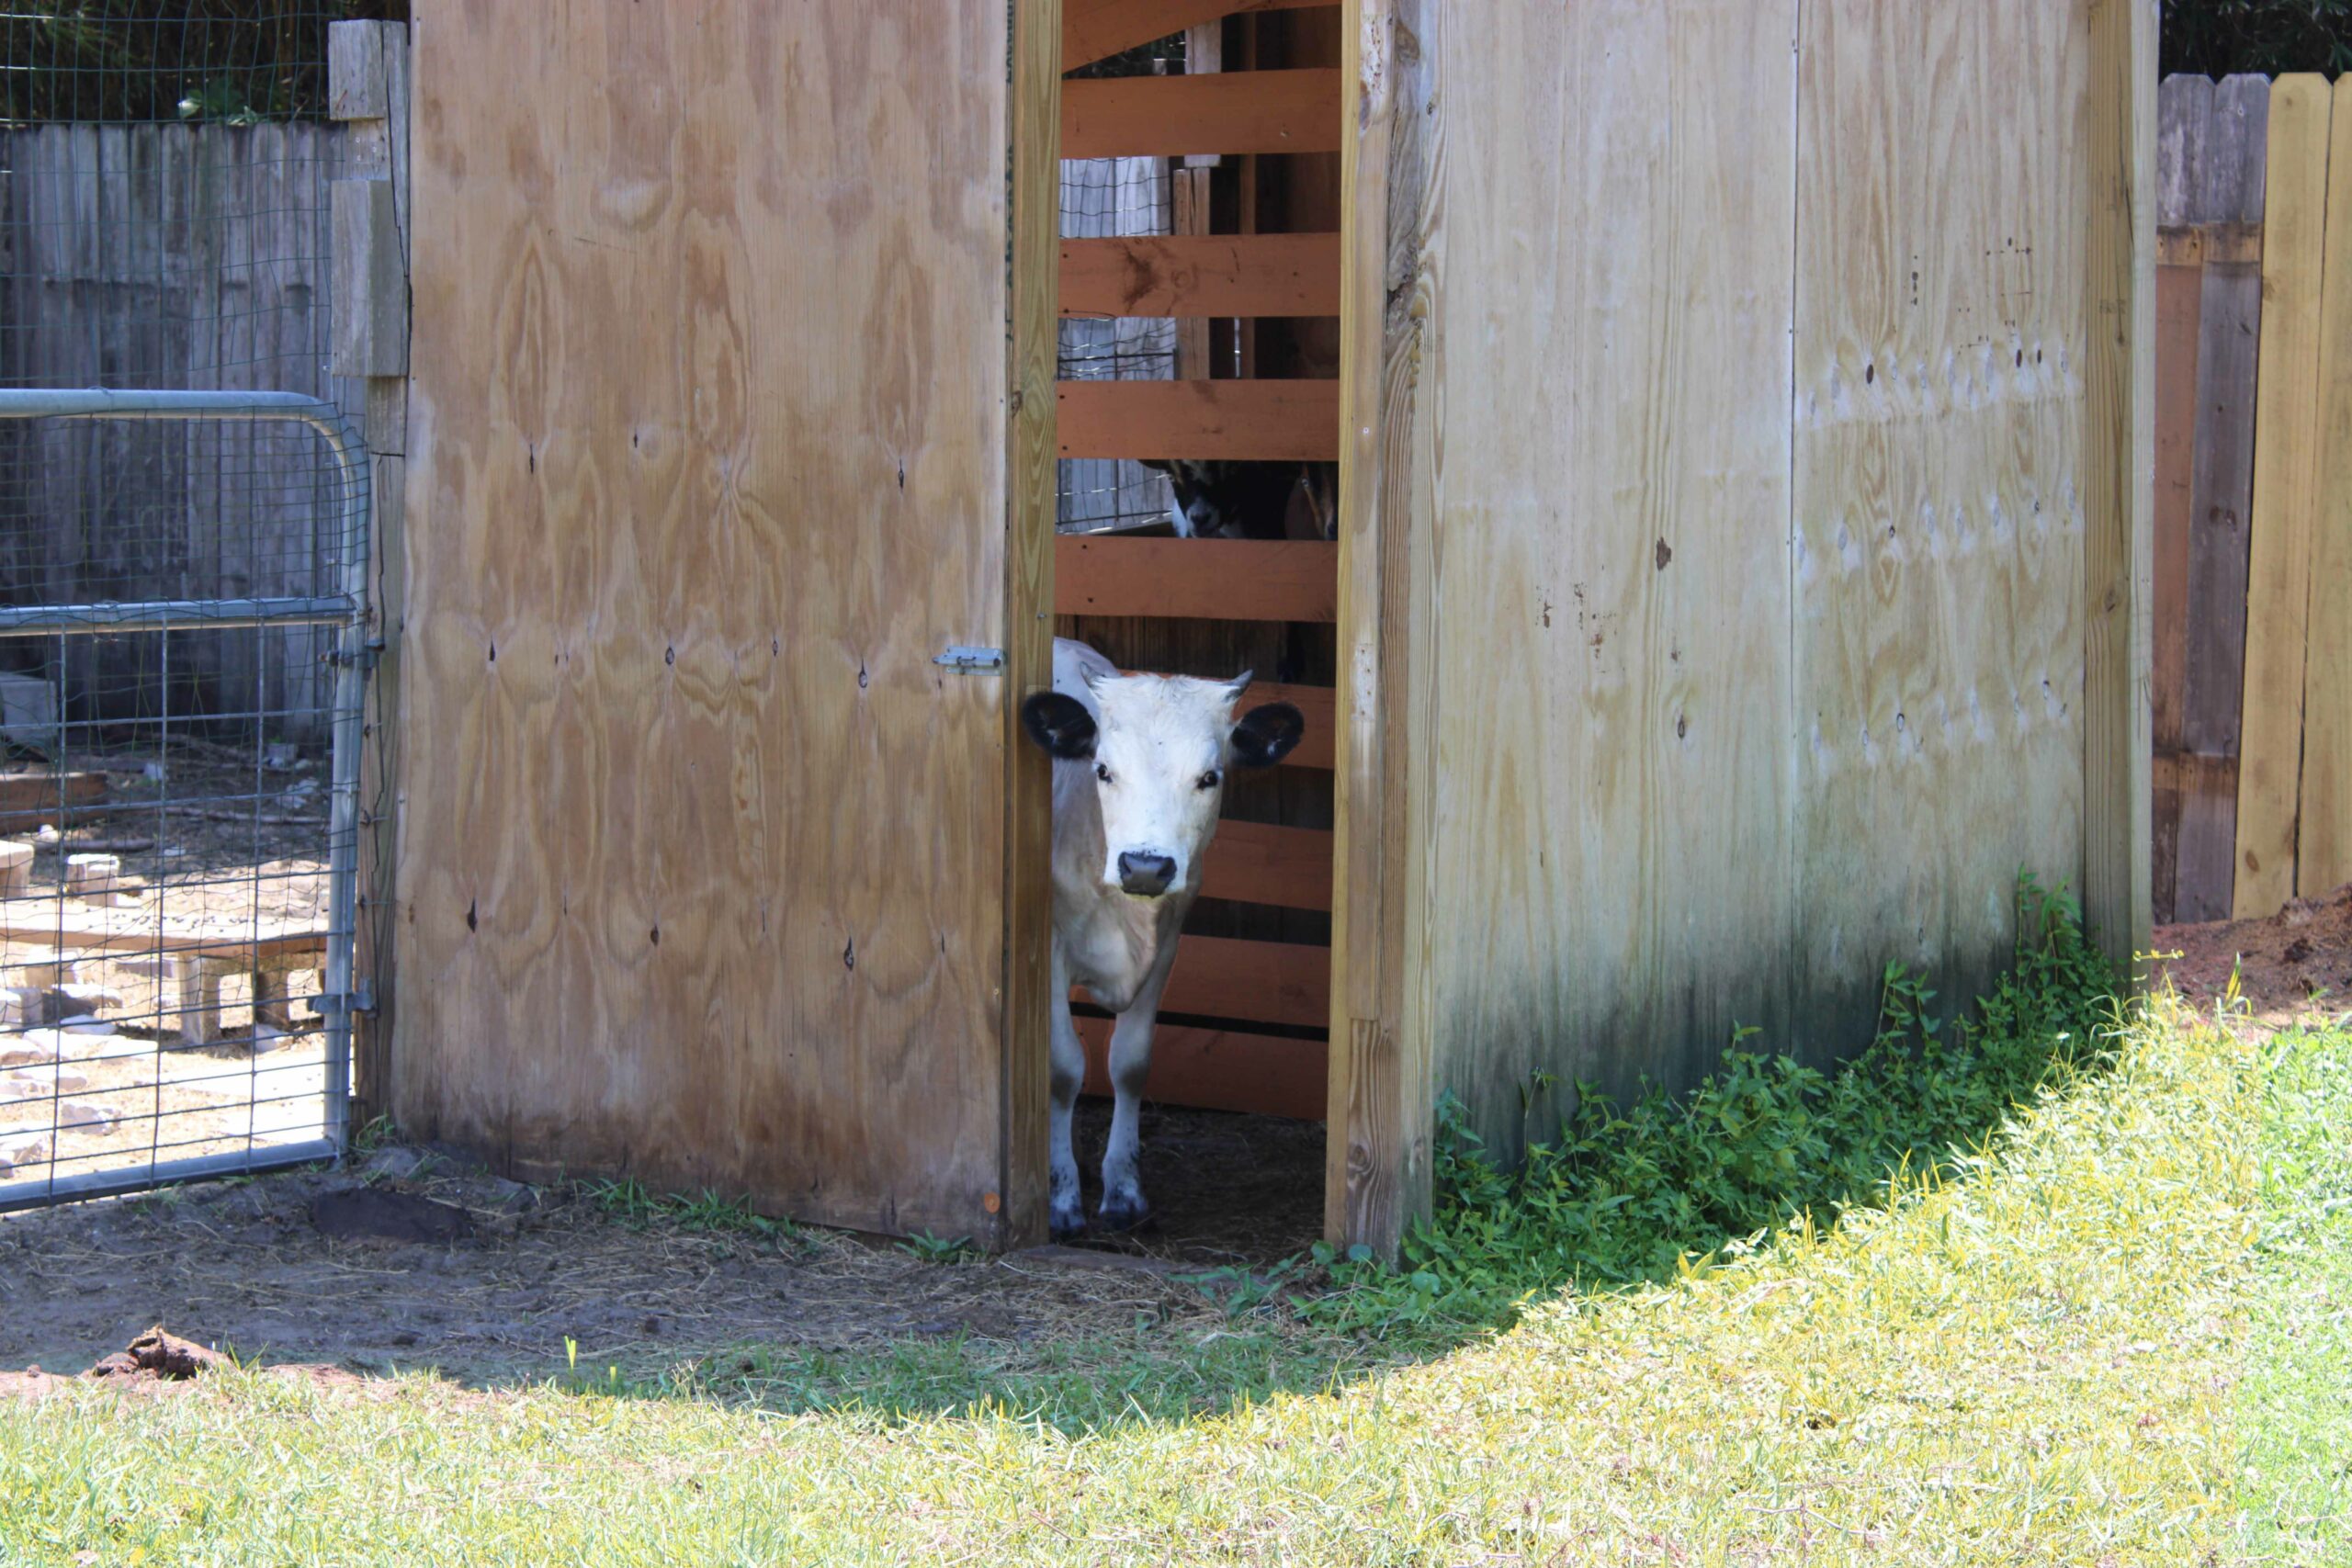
0,390,371,1211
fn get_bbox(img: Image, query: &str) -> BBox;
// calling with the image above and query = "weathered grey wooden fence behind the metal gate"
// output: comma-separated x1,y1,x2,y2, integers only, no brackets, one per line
0,122,353,739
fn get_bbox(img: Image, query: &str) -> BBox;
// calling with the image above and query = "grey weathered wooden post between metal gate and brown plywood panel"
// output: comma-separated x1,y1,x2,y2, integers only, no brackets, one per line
327,21,409,1126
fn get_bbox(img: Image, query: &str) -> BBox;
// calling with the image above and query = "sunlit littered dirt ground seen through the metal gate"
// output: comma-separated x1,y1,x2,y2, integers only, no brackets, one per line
0,739,327,1185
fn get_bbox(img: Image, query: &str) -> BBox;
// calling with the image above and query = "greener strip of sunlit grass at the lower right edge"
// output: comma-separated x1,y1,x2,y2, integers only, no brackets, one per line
2242,1027,2352,1568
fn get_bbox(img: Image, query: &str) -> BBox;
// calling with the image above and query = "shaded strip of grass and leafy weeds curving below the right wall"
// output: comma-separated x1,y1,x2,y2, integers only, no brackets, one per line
505,882,2120,1432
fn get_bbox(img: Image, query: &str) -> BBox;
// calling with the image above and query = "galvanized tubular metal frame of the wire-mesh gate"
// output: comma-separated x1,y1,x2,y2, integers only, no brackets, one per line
0,388,371,1206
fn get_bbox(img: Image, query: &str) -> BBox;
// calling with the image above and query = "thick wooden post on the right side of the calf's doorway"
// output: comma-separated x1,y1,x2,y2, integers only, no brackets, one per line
1324,0,1446,1258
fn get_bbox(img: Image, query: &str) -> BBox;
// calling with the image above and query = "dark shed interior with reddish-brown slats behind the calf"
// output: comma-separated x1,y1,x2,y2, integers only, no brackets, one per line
1054,5,1343,1265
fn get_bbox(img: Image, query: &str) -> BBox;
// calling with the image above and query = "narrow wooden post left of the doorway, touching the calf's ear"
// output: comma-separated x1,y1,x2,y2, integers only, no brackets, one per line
986,0,1063,1248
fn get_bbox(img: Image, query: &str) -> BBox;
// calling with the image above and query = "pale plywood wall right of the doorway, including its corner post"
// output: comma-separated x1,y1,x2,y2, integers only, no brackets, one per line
1331,0,2145,1175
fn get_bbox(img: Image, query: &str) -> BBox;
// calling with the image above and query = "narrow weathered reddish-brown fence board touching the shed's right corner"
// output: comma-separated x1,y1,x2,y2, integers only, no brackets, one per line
2150,75,2213,924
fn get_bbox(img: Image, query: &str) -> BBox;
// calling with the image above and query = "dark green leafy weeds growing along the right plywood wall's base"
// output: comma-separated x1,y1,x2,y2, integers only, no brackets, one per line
1310,877,2117,1333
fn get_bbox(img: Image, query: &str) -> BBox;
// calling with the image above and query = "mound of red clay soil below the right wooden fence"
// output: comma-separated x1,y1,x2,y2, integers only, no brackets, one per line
2157,884,2352,1025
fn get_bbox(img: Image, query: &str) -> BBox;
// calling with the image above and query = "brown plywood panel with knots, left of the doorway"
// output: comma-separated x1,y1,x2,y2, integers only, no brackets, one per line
395,0,1021,1236
